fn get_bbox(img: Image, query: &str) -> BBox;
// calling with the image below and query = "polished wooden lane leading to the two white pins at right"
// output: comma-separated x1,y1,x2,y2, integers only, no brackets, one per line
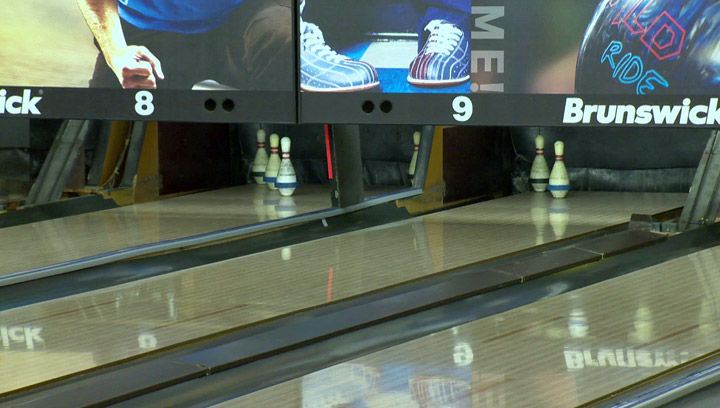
0,193,685,394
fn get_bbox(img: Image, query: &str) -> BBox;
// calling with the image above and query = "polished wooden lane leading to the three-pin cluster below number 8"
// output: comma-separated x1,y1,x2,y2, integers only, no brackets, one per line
0,185,330,276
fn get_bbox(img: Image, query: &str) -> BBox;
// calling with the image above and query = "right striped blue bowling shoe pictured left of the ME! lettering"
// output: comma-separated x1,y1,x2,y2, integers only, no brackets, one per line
408,20,470,86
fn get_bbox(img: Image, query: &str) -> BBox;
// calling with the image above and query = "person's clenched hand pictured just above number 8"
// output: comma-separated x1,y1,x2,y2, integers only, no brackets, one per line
108,45,165,89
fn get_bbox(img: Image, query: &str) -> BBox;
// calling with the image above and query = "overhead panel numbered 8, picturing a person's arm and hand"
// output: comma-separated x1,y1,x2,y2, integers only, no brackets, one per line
0,0,297,122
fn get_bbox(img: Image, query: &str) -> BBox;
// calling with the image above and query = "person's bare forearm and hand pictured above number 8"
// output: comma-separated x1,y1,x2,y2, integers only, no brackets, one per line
77,0,164,89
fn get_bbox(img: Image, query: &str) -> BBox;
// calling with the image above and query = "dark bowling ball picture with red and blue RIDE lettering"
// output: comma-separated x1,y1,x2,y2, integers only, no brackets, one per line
575,0,720,95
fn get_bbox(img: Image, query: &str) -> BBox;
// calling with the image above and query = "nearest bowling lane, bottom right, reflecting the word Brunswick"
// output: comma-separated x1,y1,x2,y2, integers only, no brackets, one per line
216,236,720,408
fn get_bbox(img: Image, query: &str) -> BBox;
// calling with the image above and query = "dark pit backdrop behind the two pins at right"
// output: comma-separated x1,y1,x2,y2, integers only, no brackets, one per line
509,127,711,192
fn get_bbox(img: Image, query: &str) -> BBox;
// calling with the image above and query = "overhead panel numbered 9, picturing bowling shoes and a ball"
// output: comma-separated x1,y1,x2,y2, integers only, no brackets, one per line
299,0,720,127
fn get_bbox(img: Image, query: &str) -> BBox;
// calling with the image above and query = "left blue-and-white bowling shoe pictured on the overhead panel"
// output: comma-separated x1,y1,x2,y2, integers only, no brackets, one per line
300,21,380,92
